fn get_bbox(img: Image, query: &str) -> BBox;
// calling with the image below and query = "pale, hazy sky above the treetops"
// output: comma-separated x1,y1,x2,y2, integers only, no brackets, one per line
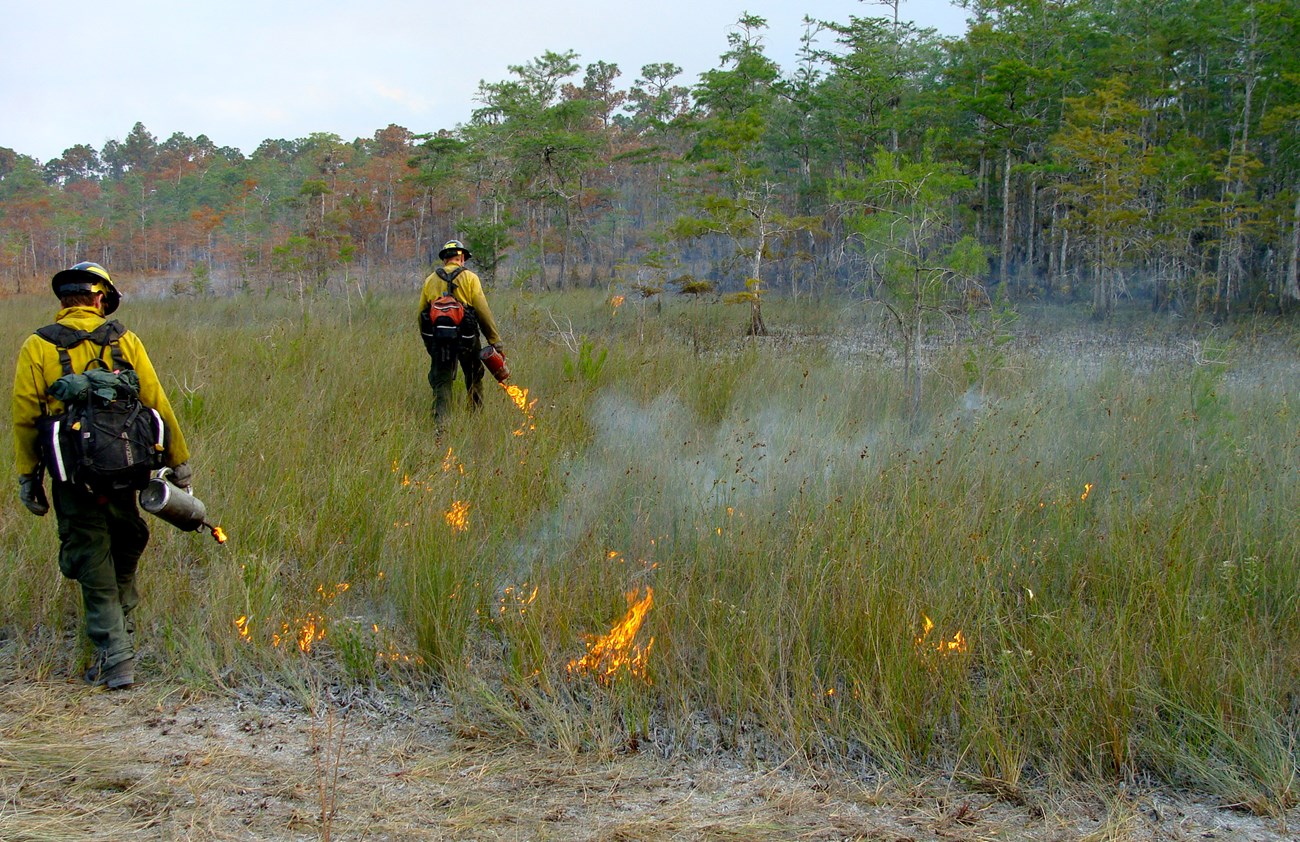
0,0,966,161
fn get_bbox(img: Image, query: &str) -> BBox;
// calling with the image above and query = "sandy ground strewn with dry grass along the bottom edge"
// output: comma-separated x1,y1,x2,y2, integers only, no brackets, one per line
0,659,1300,842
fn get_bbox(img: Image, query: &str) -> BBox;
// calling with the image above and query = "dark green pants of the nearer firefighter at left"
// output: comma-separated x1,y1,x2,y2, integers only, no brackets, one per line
52,482,150,669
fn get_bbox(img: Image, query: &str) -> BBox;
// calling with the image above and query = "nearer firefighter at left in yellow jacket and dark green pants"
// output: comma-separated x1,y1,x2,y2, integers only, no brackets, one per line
13,262,191,690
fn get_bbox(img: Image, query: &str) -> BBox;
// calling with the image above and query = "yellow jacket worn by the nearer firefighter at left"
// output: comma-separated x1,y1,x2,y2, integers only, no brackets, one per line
13,307,190,474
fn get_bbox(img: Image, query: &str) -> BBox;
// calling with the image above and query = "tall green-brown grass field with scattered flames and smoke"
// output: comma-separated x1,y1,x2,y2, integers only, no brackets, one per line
0,285,1300,812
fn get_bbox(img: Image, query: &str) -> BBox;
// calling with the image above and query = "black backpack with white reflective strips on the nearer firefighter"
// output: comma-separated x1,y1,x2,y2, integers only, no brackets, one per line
36,321,166,491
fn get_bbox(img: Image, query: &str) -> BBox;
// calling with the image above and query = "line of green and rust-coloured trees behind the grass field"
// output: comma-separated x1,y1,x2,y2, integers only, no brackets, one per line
0,0,1300,319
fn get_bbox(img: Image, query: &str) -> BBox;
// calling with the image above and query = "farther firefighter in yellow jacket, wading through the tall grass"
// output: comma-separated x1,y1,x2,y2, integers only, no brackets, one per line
420,240,504,424
